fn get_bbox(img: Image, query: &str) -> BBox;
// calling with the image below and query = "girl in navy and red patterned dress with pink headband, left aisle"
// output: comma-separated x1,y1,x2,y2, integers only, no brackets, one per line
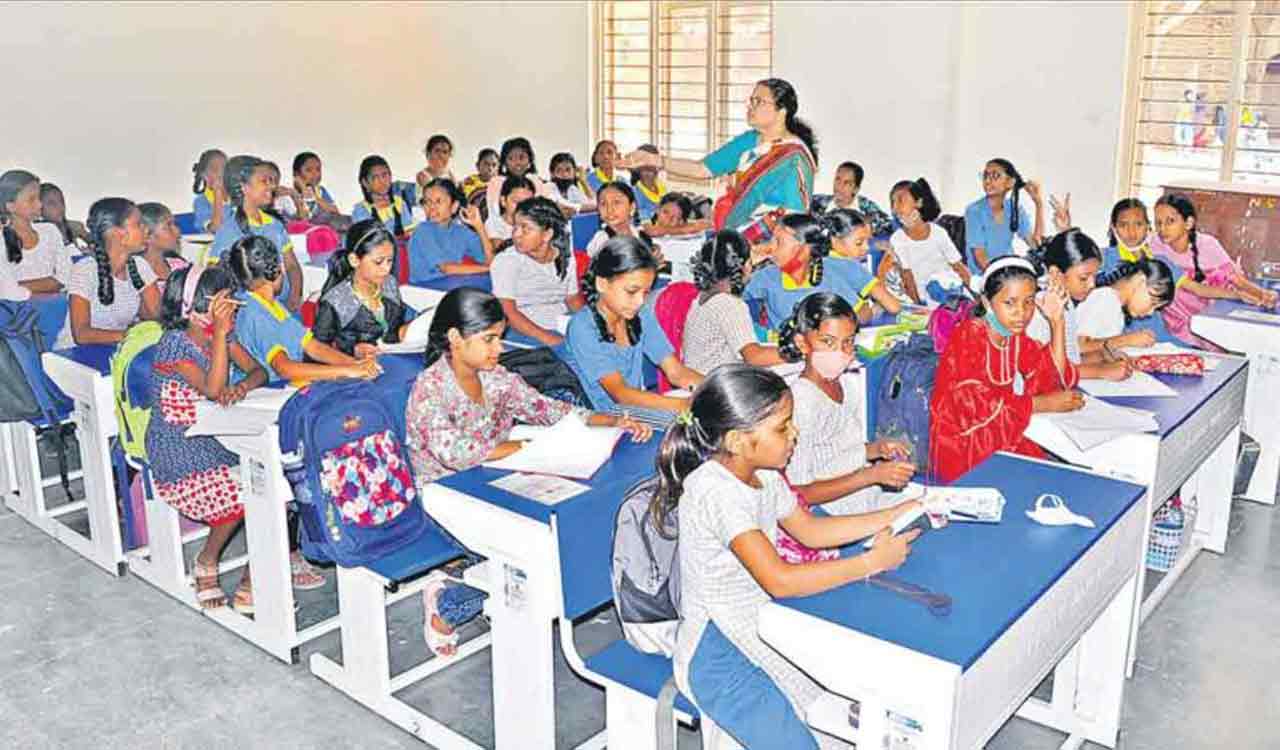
146,266,266,613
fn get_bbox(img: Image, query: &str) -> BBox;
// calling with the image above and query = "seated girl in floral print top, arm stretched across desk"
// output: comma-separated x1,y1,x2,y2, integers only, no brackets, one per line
404,287,652,657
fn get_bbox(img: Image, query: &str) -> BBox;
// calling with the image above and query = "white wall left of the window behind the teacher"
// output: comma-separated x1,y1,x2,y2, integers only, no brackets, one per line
0,0,590,216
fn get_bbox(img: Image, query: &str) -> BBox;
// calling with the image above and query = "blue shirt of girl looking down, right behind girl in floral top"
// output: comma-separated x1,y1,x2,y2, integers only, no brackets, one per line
563,306,676,411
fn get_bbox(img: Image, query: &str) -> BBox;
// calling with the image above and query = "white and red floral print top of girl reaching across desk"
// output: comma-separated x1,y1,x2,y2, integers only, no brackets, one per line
404,357,573,486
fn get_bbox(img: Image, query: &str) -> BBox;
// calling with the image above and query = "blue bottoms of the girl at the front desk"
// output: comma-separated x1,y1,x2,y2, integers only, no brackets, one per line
689,622,818,750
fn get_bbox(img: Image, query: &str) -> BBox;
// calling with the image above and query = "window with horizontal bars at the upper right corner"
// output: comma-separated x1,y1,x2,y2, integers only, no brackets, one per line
1128,0,1280,202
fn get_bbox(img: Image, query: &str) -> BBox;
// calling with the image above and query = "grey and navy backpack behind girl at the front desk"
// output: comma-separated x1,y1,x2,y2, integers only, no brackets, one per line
609,475,680,657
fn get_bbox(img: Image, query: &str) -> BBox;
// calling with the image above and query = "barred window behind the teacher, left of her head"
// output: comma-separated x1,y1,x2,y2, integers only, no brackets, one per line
595,0,773,175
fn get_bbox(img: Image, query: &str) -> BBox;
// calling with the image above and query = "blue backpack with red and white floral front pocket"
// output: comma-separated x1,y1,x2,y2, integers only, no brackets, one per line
279,380,429,567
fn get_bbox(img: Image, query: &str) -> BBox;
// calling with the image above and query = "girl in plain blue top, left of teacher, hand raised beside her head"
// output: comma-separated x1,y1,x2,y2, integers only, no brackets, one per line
408,179,493,284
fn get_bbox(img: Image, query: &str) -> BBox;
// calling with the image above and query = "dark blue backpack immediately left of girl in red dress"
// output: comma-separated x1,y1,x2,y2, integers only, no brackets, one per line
876,333,938,475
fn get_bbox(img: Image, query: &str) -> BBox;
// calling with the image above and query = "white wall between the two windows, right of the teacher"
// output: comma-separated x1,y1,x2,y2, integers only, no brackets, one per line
773,0,1129,241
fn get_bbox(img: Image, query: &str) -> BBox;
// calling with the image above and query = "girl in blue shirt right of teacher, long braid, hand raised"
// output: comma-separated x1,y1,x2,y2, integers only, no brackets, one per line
964,159,1044,274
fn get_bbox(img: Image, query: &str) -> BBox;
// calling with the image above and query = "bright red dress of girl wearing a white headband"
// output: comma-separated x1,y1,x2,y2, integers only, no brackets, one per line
929,319,1079,481
